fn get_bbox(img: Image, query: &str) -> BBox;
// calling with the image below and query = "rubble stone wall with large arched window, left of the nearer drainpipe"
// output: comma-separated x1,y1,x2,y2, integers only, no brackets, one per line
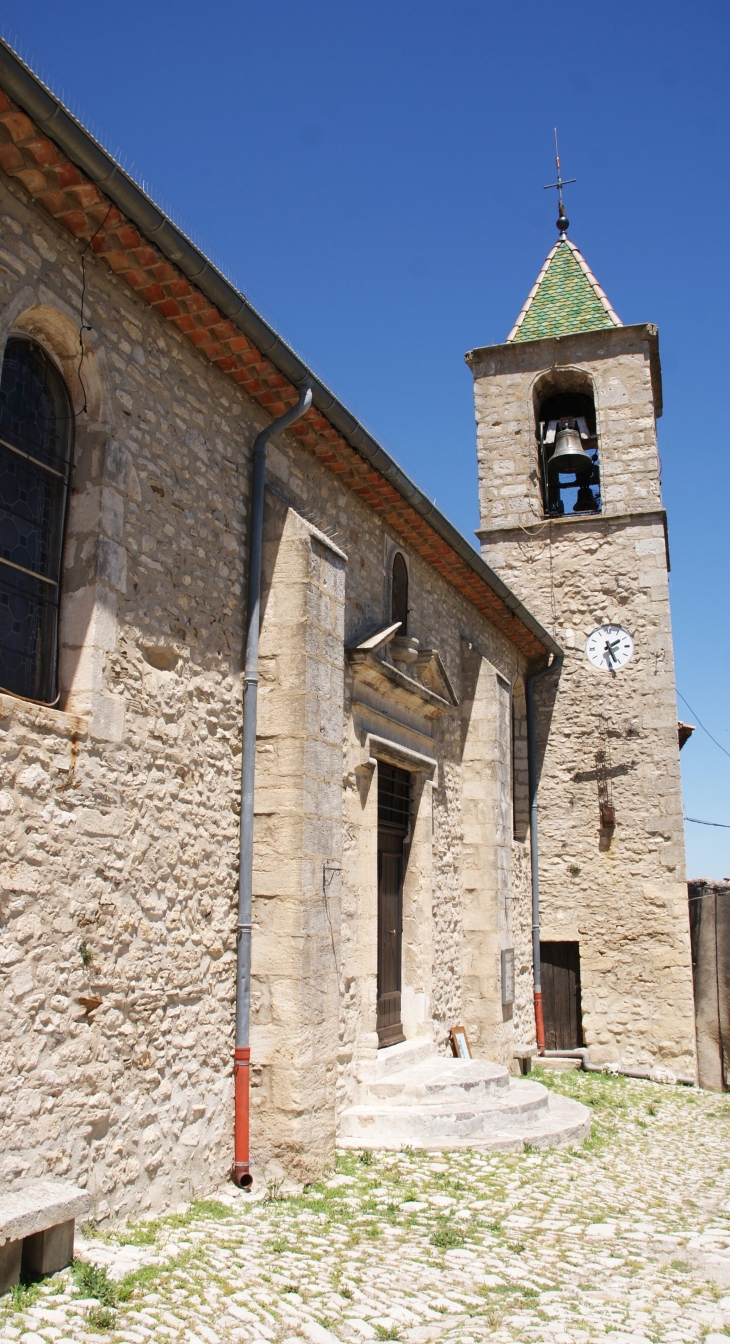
0,170,262,1216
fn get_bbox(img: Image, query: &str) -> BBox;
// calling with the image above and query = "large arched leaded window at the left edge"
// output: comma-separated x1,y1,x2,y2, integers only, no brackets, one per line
0,337,74,704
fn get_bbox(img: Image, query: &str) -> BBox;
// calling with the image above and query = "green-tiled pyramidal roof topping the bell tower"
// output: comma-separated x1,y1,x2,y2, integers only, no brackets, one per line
507,236,622,341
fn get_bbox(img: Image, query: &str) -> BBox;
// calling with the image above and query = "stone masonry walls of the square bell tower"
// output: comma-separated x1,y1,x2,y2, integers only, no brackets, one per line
469,328,694,1073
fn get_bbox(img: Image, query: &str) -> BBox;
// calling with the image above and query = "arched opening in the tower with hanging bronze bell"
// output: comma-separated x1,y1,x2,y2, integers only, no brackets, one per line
535,370,602,517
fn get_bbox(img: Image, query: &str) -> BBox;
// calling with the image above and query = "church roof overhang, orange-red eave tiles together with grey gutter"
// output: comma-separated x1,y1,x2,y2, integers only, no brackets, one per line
0,39,561,659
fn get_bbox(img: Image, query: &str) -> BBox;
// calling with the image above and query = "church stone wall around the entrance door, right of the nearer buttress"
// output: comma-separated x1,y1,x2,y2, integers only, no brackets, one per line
263,413,534,1105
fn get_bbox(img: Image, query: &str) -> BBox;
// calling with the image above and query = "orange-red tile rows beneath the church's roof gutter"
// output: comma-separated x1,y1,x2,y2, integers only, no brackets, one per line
0,89,544,657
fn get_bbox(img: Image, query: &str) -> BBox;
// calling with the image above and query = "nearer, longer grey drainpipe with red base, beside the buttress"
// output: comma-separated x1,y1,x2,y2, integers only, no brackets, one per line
233,383,312,1189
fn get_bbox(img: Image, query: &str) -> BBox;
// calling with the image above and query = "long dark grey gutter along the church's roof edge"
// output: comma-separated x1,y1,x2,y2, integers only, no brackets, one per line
0,39,562,655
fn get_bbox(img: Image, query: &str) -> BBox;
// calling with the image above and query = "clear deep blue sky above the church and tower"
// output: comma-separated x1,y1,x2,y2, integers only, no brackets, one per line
7,0,730,878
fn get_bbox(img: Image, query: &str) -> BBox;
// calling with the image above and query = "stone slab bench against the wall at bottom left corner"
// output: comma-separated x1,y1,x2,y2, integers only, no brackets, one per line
0,1179,91,1293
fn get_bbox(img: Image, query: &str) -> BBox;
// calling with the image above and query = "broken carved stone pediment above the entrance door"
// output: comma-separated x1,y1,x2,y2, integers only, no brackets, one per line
346,621,458,719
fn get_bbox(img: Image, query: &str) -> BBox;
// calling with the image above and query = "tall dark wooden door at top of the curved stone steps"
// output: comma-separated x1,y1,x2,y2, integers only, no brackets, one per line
376,763,410,1046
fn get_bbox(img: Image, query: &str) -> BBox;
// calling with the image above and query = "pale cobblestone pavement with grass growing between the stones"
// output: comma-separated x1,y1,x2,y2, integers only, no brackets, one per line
0,1074,730,1344
